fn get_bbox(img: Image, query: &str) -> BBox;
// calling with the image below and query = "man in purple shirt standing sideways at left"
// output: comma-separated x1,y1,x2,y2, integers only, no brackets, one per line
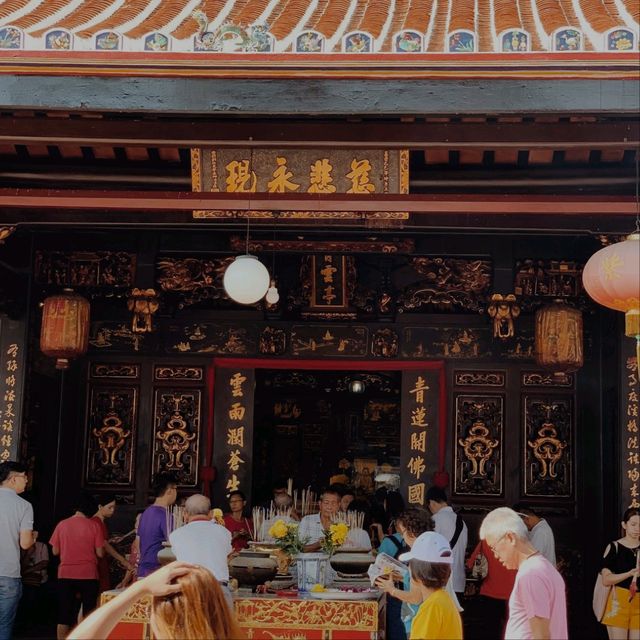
138,473,178,578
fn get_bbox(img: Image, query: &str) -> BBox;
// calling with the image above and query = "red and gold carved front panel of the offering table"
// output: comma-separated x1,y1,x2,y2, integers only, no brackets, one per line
235,598,378,632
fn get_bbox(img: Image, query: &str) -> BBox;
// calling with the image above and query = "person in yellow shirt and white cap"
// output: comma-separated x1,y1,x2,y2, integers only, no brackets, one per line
400,531,462,640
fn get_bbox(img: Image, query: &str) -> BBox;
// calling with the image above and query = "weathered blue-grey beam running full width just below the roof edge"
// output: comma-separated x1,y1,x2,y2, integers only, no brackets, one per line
0,76,640,116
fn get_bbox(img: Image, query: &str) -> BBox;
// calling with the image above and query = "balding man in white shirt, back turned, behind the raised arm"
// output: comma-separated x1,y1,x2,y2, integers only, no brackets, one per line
169,493,233,606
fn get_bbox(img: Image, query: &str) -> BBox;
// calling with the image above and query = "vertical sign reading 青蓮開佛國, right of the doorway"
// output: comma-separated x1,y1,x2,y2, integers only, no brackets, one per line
400,369,445,507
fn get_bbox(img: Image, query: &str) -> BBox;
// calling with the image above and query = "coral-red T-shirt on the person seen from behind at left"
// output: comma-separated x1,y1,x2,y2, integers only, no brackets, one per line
49,516,104,580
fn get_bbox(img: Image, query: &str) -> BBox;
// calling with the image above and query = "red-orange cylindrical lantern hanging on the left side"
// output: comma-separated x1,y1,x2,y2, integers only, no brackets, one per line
40,289,90,369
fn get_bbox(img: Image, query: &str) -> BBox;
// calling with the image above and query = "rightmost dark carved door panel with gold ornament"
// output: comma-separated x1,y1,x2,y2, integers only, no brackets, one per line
523,395,574,497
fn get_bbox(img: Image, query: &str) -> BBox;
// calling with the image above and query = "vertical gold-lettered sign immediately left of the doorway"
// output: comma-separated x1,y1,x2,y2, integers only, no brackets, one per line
213,367,255,507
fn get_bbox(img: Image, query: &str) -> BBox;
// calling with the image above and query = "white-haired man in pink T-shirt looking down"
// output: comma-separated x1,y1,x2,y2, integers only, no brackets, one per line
480,507,568,640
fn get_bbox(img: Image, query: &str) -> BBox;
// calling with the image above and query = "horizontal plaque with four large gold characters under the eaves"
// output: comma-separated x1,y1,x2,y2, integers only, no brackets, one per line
191,147,409,220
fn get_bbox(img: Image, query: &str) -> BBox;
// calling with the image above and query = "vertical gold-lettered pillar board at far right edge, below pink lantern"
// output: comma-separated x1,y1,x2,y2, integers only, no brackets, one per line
620,340,640,512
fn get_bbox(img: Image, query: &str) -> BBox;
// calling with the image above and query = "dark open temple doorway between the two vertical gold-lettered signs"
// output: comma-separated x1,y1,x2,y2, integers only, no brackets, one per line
252,369,401,503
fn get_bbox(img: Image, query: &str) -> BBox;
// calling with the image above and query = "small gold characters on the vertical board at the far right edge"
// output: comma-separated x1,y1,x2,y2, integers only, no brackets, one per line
622,357,640,509
